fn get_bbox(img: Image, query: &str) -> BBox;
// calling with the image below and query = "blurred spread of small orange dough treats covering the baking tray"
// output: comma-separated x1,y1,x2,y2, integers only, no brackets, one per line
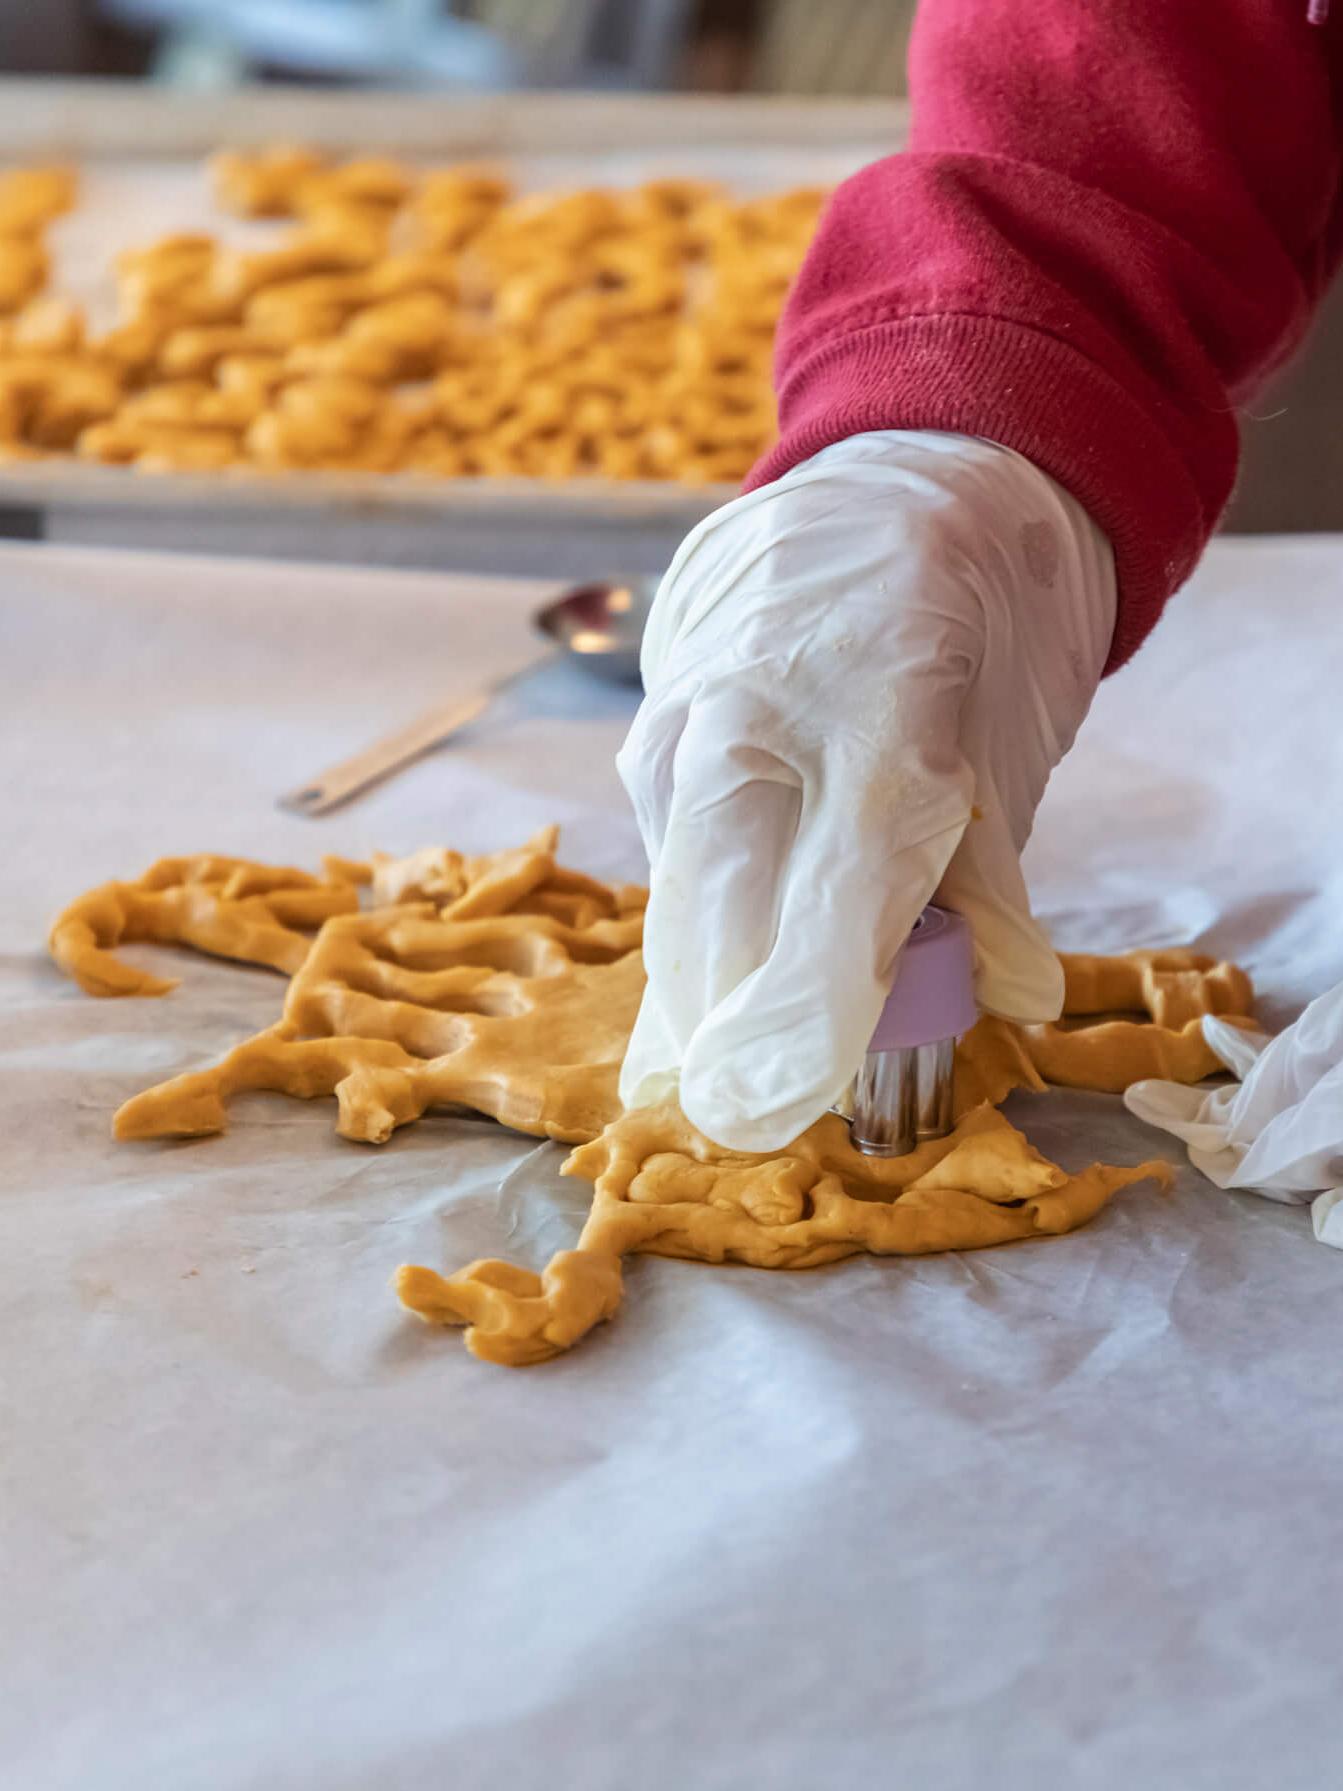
0,145,824,482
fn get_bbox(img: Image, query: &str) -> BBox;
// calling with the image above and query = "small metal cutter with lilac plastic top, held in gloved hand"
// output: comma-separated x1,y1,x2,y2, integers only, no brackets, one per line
849,906,978,1157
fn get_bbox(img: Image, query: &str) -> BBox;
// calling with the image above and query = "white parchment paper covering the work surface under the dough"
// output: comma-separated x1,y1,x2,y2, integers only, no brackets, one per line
0,539,1343,1791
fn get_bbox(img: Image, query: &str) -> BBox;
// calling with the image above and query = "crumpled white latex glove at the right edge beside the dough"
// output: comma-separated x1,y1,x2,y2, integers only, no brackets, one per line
1125,983,1343,1250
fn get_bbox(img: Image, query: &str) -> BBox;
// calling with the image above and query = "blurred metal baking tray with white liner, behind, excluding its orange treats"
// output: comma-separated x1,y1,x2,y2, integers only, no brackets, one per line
0,81,906,577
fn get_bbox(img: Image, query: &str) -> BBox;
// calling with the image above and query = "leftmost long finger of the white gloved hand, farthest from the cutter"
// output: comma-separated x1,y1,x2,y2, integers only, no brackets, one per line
630,686,800,1076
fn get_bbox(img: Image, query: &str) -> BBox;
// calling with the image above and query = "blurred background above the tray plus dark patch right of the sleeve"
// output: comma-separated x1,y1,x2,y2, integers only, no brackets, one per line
0,0,1343,530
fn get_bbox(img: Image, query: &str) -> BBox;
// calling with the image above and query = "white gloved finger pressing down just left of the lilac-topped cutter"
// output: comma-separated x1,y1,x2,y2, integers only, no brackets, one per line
680,755,971,1150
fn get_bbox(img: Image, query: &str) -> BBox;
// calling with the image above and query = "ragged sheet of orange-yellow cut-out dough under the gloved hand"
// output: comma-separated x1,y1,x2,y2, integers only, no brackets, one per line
50,827,1252,1365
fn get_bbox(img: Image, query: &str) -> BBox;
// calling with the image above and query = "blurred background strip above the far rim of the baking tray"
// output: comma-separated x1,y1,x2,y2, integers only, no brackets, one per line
0,0,913,93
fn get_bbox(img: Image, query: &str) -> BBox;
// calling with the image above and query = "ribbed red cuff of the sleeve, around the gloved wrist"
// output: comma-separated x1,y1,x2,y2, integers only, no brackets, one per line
747,313,1234,673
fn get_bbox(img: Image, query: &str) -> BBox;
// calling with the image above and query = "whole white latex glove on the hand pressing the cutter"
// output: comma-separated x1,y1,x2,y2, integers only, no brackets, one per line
618,432,1116,1150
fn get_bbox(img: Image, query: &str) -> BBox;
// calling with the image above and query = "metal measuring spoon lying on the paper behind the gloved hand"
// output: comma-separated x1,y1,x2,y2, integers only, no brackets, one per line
276,577,657,815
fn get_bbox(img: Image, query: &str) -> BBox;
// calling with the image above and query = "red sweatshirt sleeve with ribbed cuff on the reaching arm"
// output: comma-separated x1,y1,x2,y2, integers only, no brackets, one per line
748,0,1343,670
